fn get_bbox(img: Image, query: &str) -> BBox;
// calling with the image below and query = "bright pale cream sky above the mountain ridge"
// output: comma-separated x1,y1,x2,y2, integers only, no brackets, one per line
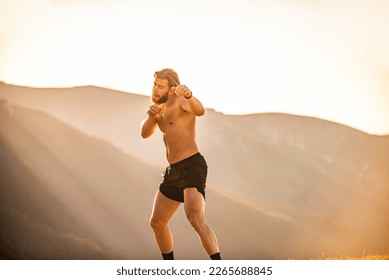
0,0,389,134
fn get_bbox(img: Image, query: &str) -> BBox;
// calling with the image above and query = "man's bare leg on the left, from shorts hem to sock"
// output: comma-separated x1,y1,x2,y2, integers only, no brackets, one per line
150,191,180,254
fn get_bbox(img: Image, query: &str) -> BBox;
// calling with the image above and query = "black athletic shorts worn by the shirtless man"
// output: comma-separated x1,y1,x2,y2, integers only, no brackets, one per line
159,153,208,202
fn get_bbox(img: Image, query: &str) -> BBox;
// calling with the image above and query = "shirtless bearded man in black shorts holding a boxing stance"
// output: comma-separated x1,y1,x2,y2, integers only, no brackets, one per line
141,68,221,260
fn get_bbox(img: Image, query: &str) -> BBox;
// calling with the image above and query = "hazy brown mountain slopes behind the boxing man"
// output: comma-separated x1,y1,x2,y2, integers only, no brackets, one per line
0,84,389,259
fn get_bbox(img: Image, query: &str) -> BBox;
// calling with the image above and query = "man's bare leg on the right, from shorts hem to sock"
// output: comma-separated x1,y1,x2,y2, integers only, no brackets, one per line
184,188,219,256
